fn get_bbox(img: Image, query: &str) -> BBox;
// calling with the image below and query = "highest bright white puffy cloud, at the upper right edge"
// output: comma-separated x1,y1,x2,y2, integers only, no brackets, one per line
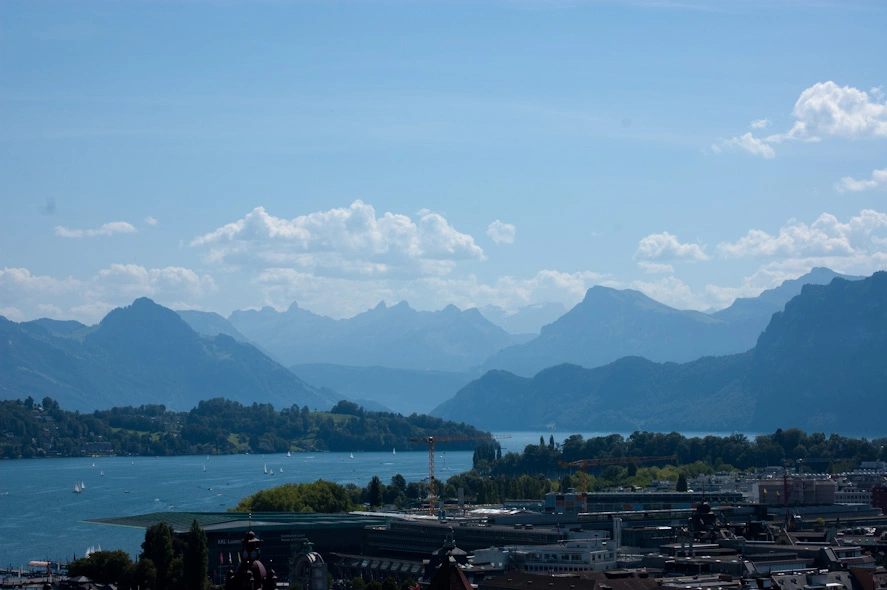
711,80,887,158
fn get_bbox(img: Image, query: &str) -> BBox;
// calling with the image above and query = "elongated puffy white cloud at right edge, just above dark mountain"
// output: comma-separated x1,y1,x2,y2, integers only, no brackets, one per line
718,209,887,259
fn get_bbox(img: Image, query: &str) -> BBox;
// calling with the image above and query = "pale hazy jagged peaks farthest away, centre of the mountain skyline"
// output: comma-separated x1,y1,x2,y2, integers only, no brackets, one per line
228,302,529,372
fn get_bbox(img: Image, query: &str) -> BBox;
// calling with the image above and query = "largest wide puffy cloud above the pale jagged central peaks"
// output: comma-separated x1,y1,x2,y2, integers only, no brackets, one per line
190,200,484,279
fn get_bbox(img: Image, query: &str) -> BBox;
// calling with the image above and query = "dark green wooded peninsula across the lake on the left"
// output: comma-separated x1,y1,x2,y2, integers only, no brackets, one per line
0,397,487,459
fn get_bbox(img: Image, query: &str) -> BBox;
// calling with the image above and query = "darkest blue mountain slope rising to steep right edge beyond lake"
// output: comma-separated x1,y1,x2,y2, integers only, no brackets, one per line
432,272,887,434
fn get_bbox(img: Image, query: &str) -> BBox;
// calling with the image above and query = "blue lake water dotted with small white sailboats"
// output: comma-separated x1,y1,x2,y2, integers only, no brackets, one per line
0,432,756,567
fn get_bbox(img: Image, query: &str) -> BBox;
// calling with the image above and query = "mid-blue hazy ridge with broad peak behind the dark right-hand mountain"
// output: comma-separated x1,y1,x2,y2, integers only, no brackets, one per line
483,268,859,377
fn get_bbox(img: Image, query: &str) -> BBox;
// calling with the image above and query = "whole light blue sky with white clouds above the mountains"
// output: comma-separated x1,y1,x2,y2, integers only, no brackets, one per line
0,0,887,323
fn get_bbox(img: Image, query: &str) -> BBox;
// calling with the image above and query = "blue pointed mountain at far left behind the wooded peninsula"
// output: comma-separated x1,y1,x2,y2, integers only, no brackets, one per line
0,298,335,411
